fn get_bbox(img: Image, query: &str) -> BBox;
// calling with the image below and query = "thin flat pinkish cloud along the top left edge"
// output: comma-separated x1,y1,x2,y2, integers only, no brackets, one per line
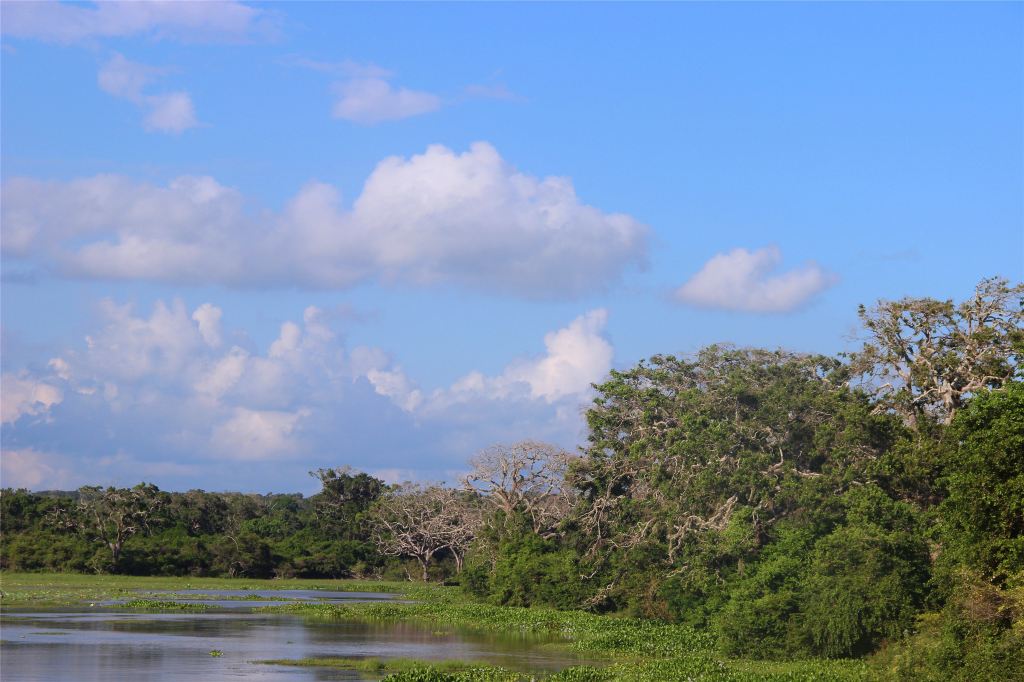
0,0,272,44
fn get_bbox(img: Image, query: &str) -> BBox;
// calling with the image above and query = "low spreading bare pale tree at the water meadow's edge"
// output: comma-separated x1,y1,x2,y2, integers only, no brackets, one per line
372,483,479,581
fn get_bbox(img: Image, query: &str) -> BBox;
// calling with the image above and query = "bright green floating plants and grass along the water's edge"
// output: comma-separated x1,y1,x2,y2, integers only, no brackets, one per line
0,573,880,682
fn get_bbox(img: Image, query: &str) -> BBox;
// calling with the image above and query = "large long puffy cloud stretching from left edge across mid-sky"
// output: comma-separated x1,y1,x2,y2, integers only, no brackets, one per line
2,142,647,298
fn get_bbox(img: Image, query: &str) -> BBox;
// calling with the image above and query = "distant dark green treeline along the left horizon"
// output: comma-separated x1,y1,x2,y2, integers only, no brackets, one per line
0,469,385,578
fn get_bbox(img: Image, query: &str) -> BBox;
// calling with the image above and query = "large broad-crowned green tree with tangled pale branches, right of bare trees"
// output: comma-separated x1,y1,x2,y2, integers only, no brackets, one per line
570,346,895,608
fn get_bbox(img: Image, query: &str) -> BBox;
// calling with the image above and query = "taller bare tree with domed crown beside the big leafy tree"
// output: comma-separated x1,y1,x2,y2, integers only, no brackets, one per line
463,440,575,537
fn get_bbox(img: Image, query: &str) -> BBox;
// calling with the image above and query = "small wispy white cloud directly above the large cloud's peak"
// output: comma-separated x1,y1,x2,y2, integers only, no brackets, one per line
332,78,441,125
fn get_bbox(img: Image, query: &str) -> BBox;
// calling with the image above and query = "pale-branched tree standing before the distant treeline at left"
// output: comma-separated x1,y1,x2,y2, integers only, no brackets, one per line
53,483,163,570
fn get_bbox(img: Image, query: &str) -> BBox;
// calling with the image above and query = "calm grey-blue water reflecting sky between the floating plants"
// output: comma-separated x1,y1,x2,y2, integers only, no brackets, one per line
0,590,579,682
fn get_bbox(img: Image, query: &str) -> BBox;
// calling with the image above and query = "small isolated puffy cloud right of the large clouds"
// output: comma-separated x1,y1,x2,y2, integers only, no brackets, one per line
676,247,837,312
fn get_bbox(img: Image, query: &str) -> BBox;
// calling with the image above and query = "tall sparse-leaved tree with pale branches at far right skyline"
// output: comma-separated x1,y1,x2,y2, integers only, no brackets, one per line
852,278,1024,424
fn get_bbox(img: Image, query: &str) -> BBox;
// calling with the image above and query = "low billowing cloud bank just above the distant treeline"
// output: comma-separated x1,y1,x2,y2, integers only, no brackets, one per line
3,301,612,489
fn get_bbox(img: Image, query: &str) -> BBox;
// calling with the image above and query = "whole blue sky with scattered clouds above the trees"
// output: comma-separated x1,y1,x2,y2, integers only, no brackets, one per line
0,1,1024,494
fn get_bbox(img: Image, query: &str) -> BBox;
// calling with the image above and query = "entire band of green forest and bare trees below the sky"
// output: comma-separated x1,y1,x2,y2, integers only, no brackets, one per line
0,279,1024,679
